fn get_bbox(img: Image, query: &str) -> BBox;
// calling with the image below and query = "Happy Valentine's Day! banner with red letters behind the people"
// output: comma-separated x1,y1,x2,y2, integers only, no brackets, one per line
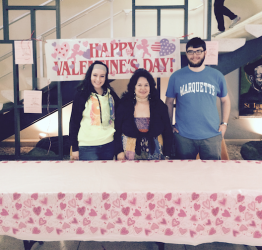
45,37,181,81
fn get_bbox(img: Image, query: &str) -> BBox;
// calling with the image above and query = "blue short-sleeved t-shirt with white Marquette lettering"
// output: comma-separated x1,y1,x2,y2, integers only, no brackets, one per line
166,66,227,140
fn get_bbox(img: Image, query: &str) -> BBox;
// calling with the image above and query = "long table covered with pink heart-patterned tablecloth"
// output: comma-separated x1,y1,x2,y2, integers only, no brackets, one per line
0,160,262,246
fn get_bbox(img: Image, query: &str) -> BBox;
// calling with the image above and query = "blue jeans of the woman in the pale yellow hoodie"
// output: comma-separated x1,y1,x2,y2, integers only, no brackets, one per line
79,141,114,160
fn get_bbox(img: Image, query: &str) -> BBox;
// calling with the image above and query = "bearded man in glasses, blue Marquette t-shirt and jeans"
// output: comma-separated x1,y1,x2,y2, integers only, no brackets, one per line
166,37,230,160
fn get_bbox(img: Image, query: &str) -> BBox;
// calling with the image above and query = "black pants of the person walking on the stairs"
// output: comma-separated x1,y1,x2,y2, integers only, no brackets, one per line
214,0,237,31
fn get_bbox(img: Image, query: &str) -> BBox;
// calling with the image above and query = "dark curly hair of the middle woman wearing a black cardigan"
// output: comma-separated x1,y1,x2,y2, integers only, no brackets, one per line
122,68,159,105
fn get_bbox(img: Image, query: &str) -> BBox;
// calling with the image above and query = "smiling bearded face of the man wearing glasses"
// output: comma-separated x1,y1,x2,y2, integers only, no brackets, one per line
186,47,207,68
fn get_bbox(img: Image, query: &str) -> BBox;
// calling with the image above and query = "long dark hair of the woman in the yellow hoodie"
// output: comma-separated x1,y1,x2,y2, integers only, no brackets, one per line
77,61,112,100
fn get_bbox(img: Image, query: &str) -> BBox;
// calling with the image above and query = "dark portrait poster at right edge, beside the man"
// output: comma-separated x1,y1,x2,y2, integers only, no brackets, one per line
239,56,262,117
